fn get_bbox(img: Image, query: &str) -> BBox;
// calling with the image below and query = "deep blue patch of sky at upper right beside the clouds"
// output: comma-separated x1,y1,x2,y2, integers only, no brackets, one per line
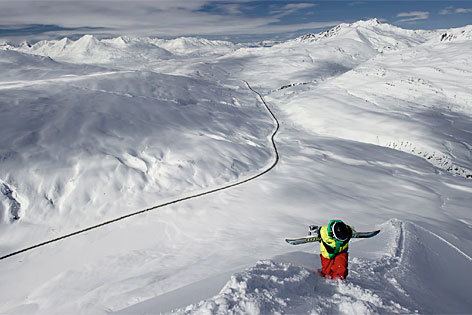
202,1,472,29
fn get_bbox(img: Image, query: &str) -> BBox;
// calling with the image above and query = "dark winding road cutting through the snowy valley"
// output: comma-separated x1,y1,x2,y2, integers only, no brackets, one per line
0,81,280,260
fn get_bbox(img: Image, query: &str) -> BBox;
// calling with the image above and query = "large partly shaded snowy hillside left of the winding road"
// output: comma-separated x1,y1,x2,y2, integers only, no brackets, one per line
0,51,272,246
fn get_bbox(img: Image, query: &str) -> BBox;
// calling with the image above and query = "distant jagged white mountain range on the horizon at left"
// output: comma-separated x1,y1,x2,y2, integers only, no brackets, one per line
0,35,237,67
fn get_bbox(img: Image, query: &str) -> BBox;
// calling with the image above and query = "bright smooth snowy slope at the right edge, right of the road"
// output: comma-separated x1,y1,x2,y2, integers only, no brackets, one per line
274,27,472,178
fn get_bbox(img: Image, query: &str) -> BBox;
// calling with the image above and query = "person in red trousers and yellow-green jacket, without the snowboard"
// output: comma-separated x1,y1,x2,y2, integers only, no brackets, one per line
318,220,353,279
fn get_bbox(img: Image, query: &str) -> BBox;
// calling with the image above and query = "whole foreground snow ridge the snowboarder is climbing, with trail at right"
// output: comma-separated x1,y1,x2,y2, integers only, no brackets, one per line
177,220,472,314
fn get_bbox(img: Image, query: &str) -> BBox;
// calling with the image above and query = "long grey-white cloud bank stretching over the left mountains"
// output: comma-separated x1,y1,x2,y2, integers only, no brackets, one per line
0,0,339,36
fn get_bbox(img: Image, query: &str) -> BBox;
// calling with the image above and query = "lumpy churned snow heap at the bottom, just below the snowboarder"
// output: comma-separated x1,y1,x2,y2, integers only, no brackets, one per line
177,257,406,314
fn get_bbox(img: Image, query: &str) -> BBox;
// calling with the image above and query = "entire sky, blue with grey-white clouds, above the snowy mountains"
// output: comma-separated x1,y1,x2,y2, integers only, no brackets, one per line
0,0,472,41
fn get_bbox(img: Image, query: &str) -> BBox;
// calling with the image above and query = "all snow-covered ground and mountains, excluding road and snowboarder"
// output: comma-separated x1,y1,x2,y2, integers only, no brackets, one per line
0,20,472,314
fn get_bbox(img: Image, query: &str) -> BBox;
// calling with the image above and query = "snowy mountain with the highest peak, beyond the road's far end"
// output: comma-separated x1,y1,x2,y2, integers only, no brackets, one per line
212,19,436,95
